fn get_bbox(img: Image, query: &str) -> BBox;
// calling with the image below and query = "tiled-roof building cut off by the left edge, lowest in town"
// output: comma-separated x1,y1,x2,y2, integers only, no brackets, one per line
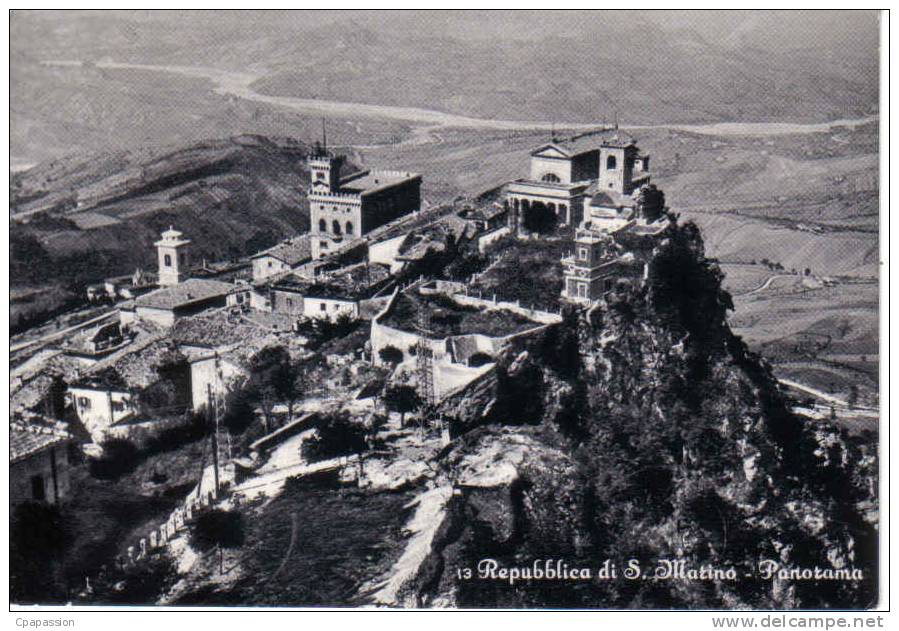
9,422,71,506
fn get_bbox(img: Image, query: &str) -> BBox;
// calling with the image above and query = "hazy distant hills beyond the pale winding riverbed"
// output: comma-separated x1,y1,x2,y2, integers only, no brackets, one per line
11,11,878,138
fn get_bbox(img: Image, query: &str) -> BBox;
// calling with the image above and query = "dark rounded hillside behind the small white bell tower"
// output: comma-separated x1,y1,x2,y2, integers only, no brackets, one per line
10,136,309,327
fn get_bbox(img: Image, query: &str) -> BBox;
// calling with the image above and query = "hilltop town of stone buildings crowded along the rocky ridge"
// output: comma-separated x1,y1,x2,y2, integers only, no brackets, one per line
10,127,876,606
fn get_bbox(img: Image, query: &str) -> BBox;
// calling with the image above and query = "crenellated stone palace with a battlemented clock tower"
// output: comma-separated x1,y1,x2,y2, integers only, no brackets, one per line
308,145,421,259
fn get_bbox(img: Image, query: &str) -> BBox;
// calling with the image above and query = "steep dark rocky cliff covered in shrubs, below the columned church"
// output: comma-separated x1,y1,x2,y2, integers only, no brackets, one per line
410,224,877,608
